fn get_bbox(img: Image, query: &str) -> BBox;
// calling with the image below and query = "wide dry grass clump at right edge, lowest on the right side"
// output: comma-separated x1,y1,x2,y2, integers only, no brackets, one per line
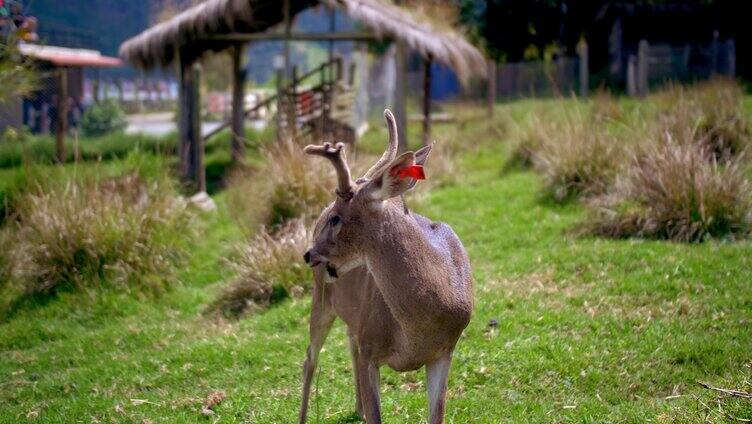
583,135,752,242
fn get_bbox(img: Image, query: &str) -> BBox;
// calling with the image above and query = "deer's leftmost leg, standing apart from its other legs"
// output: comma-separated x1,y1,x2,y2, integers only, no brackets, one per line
299,281,336,424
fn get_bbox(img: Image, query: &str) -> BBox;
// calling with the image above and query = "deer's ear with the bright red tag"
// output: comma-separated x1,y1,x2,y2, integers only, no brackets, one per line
364,152,425,200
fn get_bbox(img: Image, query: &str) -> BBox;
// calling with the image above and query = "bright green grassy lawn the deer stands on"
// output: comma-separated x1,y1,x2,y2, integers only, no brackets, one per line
0,101,752,423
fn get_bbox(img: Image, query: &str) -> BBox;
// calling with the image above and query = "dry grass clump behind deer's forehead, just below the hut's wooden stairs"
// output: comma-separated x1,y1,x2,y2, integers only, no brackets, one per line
228,141,335,233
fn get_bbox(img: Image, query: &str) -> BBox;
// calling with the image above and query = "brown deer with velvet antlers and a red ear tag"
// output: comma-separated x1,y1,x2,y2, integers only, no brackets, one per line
299,109,473,424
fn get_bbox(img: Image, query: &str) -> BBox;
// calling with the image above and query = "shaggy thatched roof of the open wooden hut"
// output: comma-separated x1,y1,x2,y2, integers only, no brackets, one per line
120,0,486,81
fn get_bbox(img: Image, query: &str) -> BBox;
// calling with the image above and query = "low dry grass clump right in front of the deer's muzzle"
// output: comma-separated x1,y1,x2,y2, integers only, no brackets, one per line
208,219,313,318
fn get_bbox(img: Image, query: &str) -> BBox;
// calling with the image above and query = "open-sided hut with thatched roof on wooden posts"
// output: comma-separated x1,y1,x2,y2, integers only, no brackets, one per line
120,0,486,188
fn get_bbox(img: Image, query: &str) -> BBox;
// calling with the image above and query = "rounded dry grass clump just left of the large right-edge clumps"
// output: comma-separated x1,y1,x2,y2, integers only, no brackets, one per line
532,107,623,202
